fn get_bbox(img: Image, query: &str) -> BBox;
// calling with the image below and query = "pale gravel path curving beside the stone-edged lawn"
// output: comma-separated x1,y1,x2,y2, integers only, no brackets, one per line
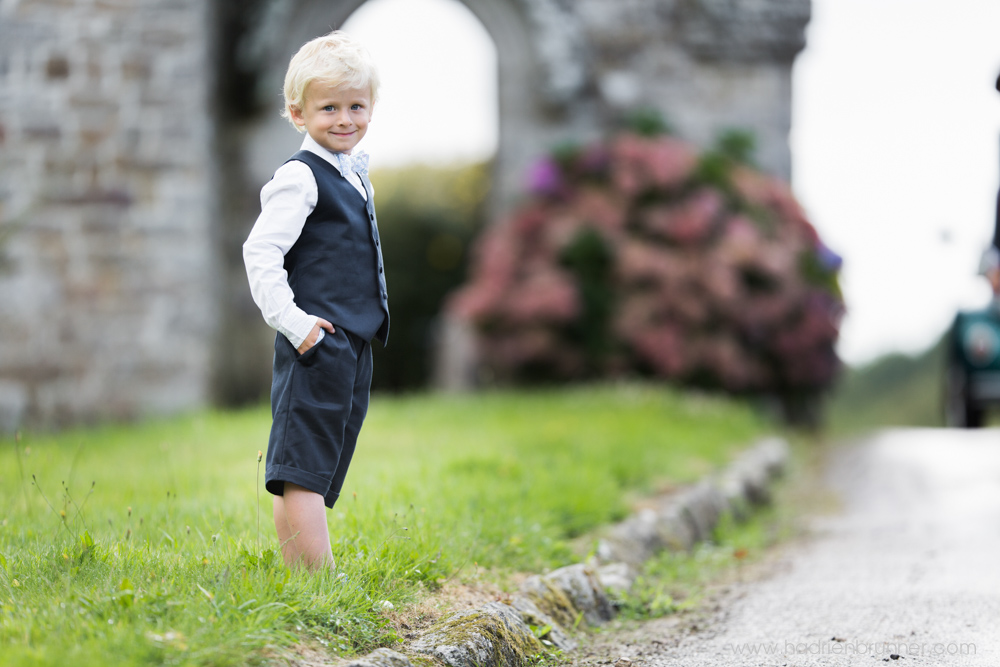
567,430,1000,667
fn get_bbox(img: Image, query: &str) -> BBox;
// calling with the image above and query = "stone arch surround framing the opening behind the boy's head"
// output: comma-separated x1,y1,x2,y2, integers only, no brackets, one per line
214,0,565,403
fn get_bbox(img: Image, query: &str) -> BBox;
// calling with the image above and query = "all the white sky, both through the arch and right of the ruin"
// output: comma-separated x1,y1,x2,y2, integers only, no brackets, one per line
344,0,1000,363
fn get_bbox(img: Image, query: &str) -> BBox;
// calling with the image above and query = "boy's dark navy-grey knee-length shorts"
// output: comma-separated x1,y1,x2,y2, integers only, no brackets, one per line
264,327,372,507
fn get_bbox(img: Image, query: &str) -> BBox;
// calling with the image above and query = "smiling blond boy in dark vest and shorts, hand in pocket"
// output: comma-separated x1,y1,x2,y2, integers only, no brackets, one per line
243,31,389,570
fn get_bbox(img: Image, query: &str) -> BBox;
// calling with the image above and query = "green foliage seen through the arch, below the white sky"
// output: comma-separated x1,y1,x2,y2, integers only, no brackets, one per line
372,164,490,391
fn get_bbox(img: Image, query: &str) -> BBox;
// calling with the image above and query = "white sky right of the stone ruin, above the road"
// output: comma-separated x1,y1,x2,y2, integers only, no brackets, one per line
792,0,1000,362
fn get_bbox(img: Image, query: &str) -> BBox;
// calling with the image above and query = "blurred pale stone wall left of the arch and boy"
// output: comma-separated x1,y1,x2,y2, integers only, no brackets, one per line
0,0,215,431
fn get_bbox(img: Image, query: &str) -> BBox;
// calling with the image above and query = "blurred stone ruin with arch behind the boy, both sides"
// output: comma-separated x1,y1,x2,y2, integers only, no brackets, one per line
0,0,810,427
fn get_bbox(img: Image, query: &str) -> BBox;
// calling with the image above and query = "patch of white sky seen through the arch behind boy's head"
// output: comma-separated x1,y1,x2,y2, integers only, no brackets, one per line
343,0,499,166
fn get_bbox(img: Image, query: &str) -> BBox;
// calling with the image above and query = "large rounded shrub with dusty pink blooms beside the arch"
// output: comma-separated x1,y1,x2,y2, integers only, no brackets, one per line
447,134,843,396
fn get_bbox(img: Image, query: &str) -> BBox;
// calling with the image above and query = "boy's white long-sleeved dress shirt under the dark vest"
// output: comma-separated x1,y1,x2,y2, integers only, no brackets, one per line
243,134,368,349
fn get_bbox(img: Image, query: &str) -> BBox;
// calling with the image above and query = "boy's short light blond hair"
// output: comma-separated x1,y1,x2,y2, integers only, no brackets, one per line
281,30,379,132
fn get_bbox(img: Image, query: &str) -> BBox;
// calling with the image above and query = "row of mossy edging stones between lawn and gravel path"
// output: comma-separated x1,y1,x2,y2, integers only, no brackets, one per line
340,438,789,667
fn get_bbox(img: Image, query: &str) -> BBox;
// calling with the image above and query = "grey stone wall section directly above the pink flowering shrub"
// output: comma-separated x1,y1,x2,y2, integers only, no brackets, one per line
578,0,811,179
